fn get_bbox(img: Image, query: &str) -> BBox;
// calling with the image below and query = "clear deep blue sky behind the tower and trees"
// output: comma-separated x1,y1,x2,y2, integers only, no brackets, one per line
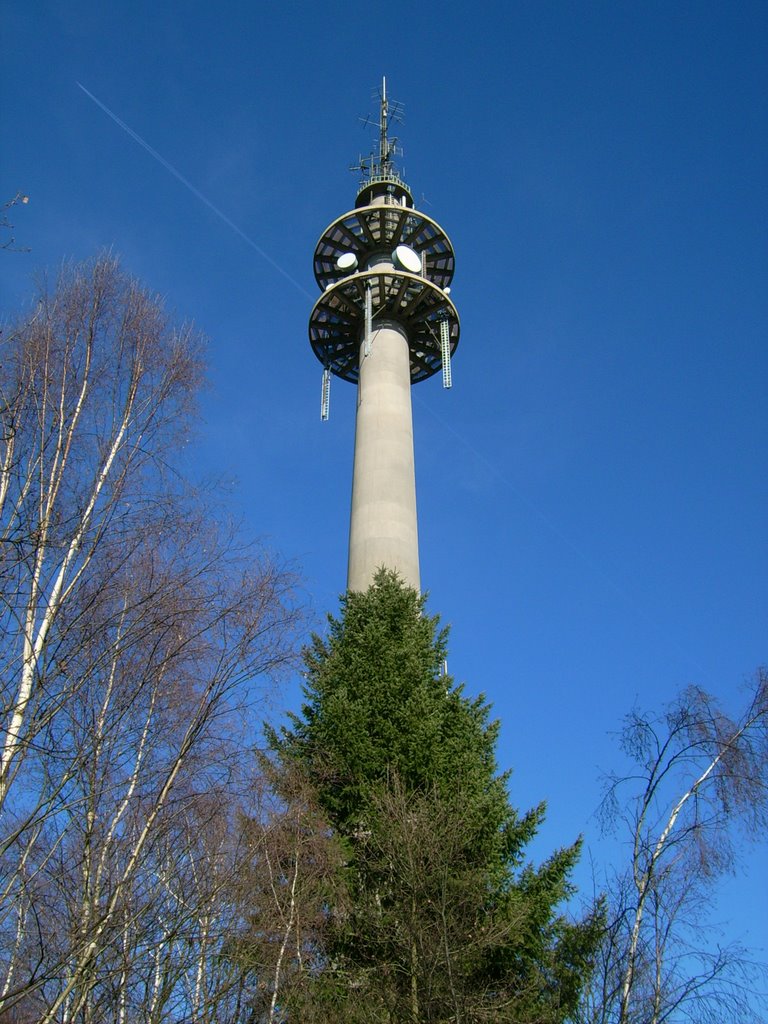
0,0,768,966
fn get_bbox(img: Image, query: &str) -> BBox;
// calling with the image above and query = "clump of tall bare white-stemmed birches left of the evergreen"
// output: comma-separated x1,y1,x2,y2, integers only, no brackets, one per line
0,257,295,1024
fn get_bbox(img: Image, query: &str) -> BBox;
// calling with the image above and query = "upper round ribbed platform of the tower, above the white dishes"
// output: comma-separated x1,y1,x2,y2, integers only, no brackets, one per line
314,205,455,289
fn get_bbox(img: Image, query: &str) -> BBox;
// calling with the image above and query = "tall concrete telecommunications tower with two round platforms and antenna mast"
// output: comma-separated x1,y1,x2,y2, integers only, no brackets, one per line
309,79,459,591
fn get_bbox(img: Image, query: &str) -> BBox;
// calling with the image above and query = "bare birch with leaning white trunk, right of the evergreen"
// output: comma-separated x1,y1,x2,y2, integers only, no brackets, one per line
580,670,768,1024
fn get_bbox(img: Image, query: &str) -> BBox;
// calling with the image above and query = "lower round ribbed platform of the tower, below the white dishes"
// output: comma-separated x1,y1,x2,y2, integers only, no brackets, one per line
309,269,459,384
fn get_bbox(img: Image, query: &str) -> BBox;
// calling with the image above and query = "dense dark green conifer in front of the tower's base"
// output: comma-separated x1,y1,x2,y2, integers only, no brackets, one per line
271,570,600,1024
